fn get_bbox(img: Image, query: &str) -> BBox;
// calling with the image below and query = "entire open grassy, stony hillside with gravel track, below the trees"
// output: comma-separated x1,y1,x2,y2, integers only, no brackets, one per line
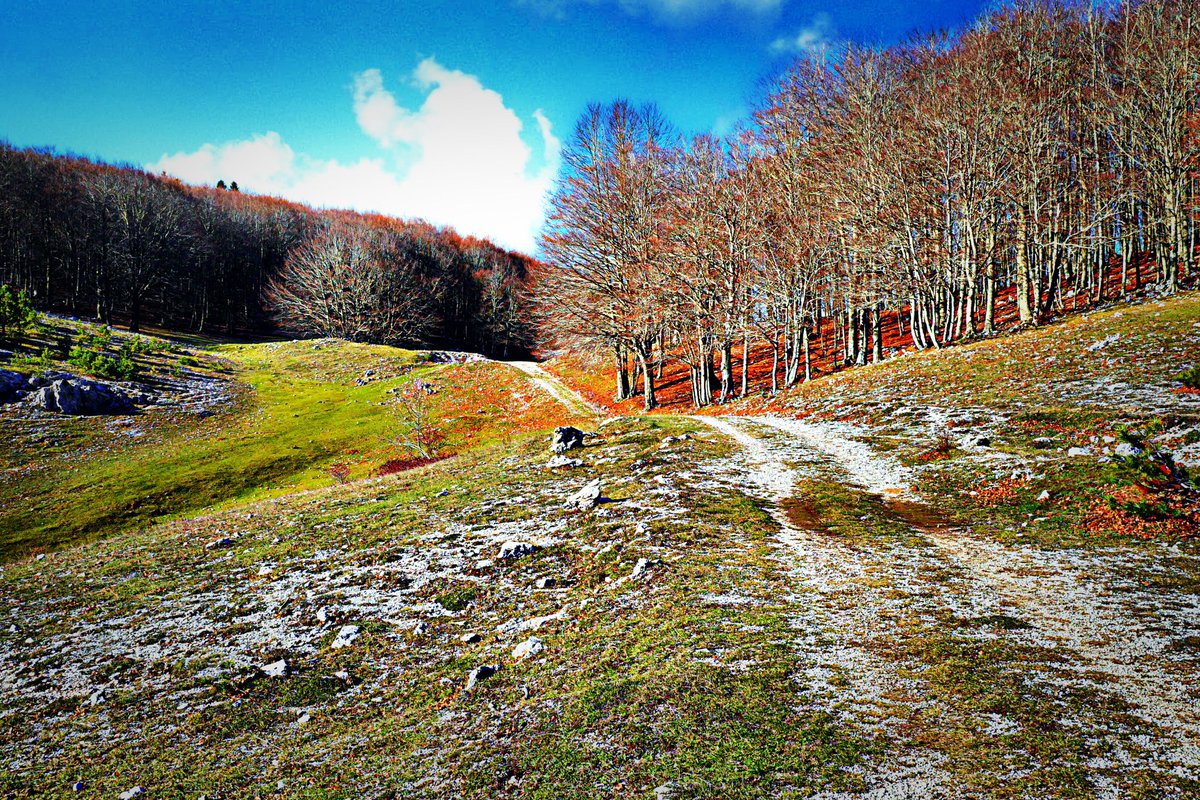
0,293,1200,798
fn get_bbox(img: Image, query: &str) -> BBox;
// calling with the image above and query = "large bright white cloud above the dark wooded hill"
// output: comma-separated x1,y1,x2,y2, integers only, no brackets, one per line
148,59,560,252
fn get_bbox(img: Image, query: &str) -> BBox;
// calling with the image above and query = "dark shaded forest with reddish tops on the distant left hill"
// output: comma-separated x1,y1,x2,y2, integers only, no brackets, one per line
0,142,533,355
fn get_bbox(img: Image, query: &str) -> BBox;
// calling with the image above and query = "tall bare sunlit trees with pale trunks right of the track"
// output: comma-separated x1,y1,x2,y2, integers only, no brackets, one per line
538,0,1200,409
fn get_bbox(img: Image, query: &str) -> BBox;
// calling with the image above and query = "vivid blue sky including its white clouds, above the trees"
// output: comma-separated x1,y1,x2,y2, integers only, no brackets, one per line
0,0,985,251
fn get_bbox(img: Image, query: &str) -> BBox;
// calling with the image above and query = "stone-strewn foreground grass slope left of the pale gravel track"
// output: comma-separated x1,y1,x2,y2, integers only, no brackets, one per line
0,419,875,798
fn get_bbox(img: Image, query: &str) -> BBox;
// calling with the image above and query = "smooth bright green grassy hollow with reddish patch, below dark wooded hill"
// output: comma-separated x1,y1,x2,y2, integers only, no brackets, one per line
0,328,576,559
